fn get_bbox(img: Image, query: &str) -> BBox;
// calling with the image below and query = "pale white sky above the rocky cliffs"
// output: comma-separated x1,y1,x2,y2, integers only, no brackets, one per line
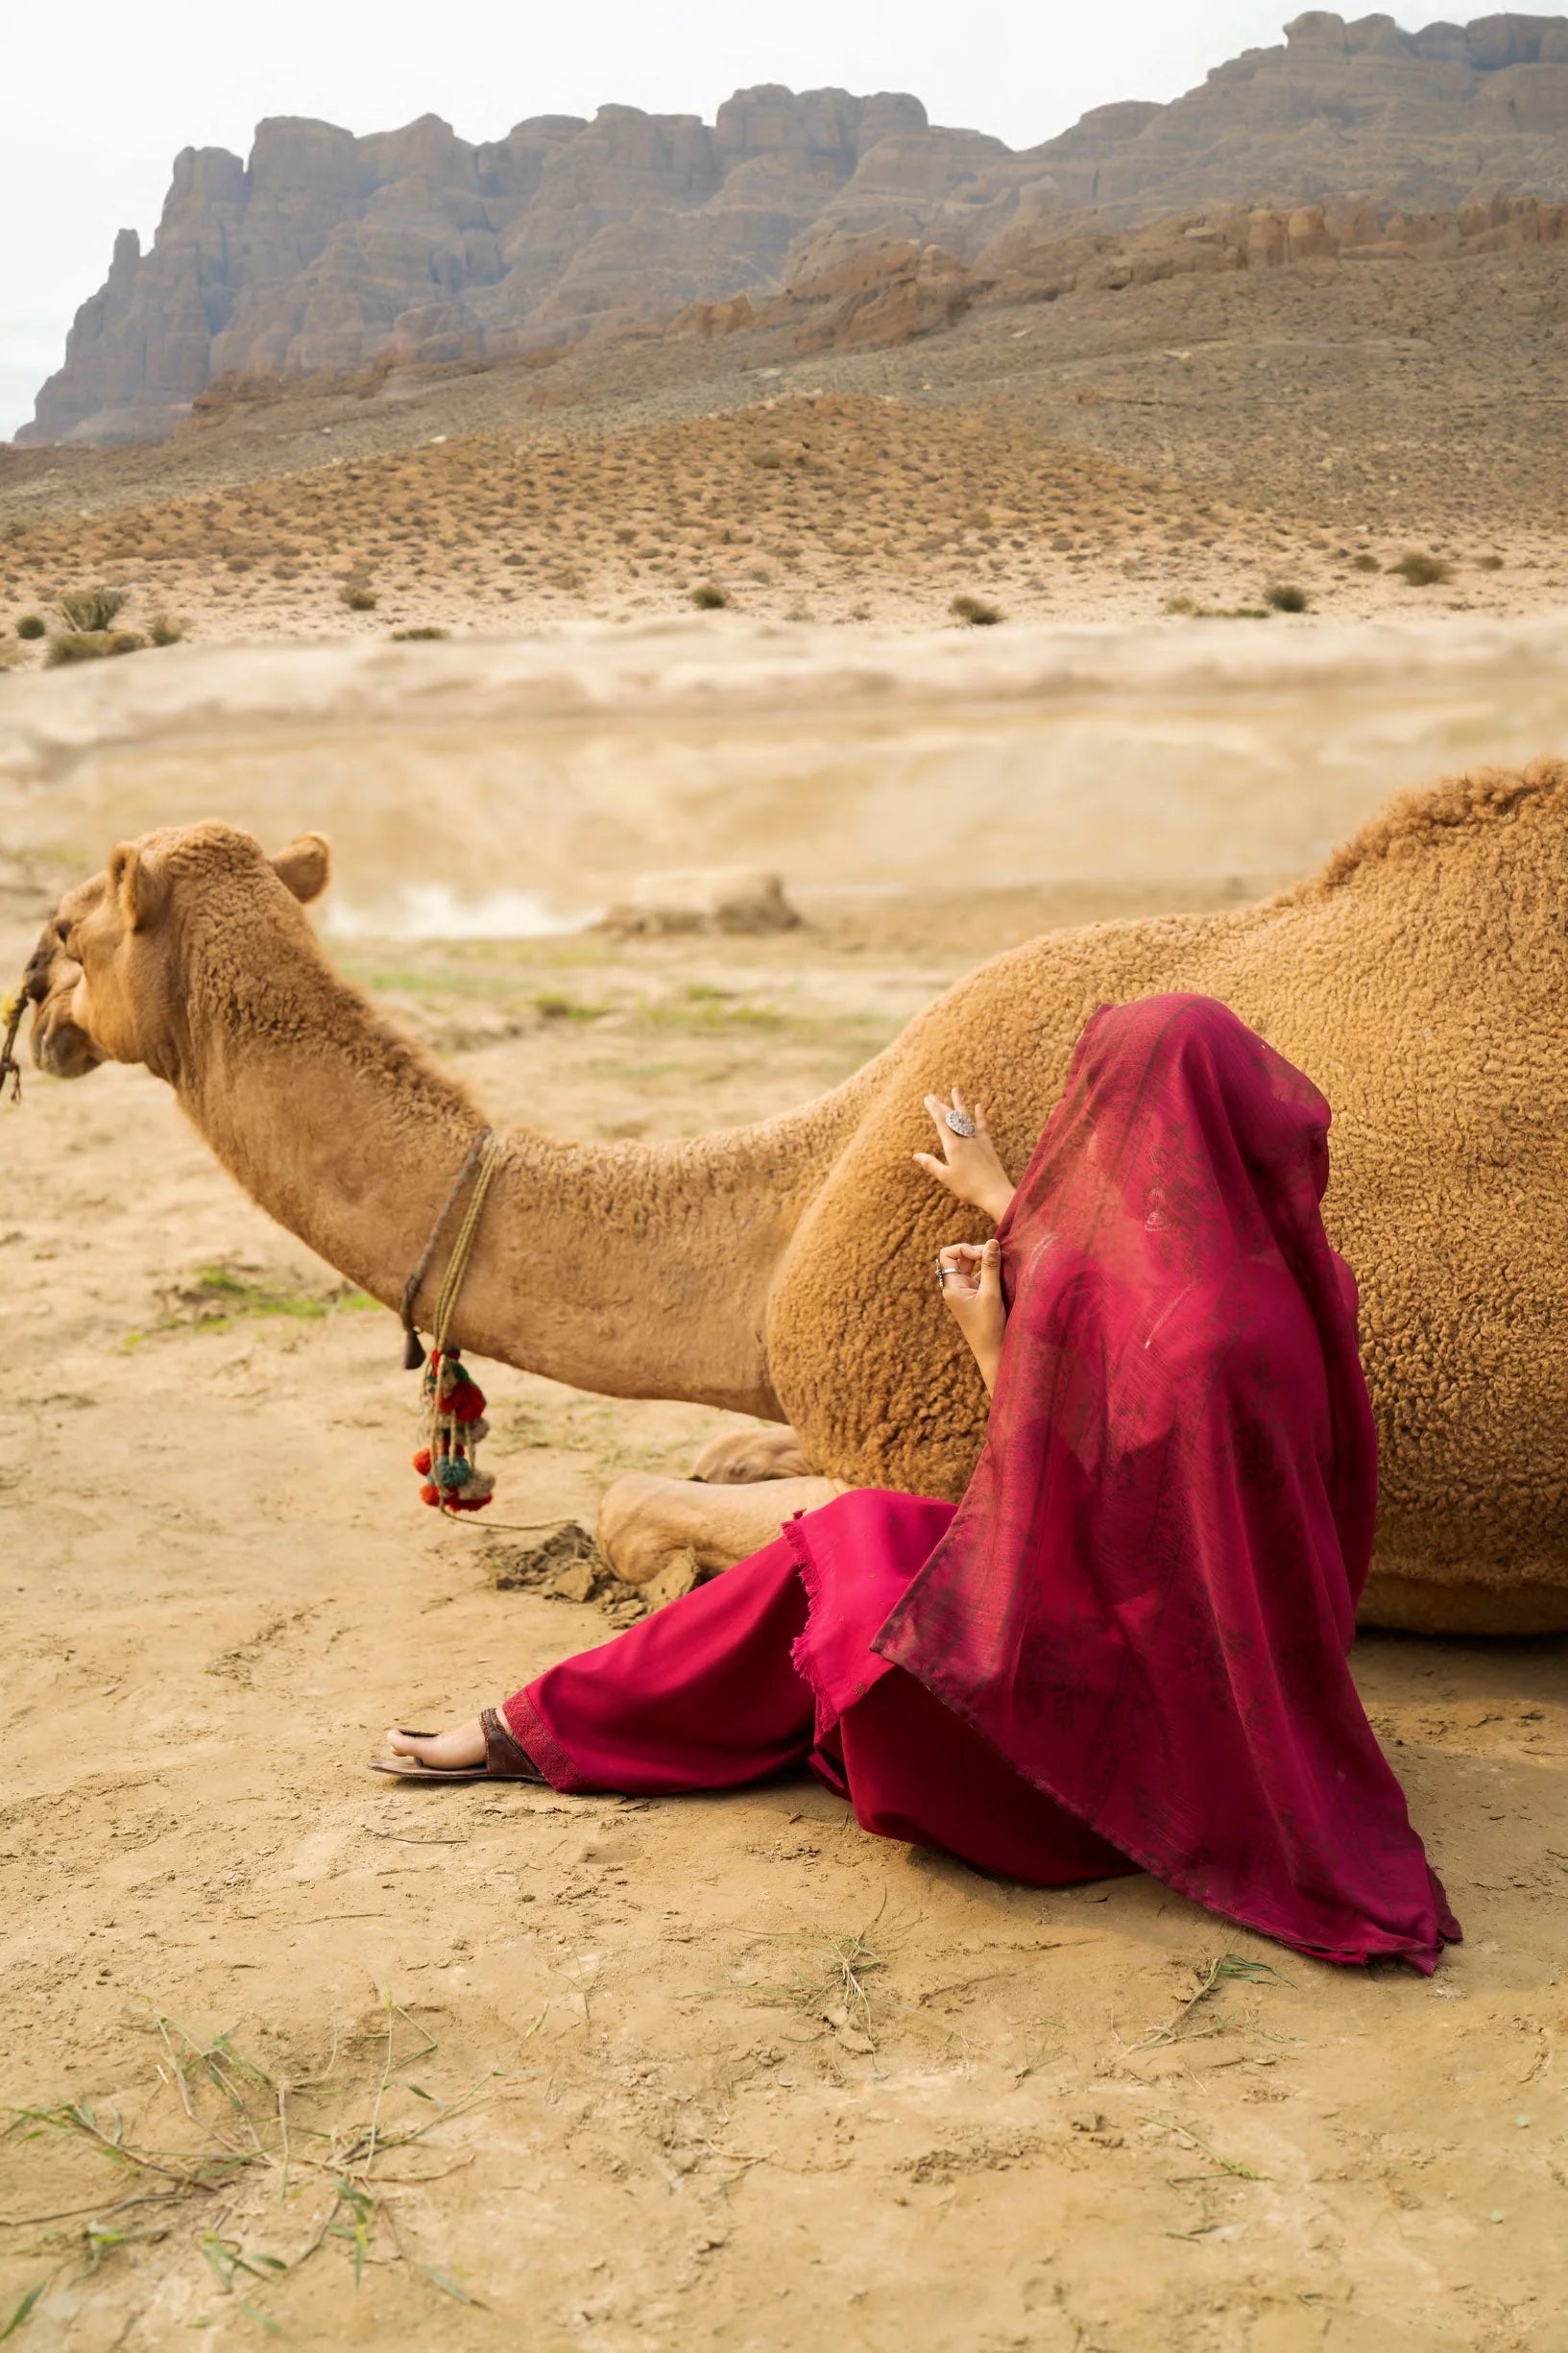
0,0,1441,435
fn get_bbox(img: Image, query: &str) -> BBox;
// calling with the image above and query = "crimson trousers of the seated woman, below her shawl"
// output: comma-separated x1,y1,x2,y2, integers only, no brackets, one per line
503,1539,1138,1887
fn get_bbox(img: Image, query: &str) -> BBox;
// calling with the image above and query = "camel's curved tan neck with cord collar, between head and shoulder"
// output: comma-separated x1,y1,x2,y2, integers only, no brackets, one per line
177,908,832,1414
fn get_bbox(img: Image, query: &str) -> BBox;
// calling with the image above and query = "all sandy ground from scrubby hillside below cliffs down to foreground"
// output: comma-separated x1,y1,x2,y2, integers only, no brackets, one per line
0,263,1568,2353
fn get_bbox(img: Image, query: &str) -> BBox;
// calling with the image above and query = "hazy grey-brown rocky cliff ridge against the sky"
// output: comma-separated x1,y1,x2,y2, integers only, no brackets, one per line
19,10,1568,443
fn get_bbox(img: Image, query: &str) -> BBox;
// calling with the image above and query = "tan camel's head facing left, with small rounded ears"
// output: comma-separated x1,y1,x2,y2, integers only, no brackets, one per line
23,826,329,1078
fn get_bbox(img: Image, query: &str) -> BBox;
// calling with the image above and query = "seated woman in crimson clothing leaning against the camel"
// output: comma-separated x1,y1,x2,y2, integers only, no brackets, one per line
381,995,1459,1972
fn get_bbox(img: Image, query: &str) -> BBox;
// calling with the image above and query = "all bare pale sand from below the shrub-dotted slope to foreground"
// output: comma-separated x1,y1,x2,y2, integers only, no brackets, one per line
0,614,1568,2353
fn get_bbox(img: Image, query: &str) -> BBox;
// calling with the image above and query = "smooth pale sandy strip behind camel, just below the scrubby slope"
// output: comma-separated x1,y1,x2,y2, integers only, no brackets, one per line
0,610,1568,927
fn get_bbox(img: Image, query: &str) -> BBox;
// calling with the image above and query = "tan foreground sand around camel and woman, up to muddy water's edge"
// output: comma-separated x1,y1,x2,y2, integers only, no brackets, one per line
0,899,1568,2353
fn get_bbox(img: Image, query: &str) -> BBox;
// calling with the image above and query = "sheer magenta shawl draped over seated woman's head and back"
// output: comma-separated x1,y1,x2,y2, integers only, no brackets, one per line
875,995,1459,1972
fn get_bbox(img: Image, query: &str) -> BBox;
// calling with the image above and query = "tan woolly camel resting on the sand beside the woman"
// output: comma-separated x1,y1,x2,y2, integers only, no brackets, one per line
28,760,1568,1633
